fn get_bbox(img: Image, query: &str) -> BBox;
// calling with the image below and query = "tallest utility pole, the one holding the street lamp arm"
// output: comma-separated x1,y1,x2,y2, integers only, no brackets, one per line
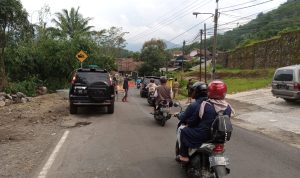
211,0,219,80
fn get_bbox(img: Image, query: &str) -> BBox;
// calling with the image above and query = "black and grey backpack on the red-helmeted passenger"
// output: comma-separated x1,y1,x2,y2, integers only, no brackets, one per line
211,111,233,143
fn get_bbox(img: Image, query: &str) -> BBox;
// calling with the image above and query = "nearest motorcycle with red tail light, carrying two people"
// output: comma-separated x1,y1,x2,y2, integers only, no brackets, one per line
174,103,230,178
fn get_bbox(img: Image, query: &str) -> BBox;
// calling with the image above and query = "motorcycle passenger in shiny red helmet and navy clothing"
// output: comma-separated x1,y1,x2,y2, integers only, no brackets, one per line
176,80,234,162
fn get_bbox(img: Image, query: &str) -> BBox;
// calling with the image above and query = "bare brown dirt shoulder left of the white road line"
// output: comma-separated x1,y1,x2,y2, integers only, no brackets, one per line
0,94,68,177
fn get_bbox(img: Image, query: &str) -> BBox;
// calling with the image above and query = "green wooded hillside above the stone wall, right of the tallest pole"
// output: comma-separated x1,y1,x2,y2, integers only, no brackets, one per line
218,0,300,51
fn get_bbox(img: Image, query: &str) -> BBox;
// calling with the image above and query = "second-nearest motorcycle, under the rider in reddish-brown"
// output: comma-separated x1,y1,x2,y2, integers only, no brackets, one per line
154,100,172,127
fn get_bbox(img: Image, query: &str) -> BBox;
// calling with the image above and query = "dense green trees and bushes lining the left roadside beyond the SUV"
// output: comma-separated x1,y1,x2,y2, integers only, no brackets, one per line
0,0,129,96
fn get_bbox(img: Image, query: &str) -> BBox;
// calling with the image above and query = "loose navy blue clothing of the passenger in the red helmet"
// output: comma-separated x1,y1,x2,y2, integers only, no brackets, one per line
180,101,232,148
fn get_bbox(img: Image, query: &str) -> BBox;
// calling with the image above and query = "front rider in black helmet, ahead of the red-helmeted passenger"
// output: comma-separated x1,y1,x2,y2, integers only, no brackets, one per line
177,82,208,156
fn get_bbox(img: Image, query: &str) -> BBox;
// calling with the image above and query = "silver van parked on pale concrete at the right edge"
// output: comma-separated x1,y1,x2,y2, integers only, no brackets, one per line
272,65,300,101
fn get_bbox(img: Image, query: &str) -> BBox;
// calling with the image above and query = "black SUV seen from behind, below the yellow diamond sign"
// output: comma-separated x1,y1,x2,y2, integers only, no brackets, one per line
69,68,115,114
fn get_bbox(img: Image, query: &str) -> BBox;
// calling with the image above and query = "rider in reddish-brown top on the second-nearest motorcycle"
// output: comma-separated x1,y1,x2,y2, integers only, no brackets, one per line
154,77,173,110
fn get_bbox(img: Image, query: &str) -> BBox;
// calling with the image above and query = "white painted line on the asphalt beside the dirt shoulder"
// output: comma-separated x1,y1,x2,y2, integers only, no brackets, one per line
38,130,70,178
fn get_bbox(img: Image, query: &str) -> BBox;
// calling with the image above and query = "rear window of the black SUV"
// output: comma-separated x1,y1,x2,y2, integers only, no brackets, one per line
77,72,108,84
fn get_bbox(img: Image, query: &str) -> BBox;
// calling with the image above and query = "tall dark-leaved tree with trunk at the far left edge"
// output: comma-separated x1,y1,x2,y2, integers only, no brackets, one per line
0,0,29,90
